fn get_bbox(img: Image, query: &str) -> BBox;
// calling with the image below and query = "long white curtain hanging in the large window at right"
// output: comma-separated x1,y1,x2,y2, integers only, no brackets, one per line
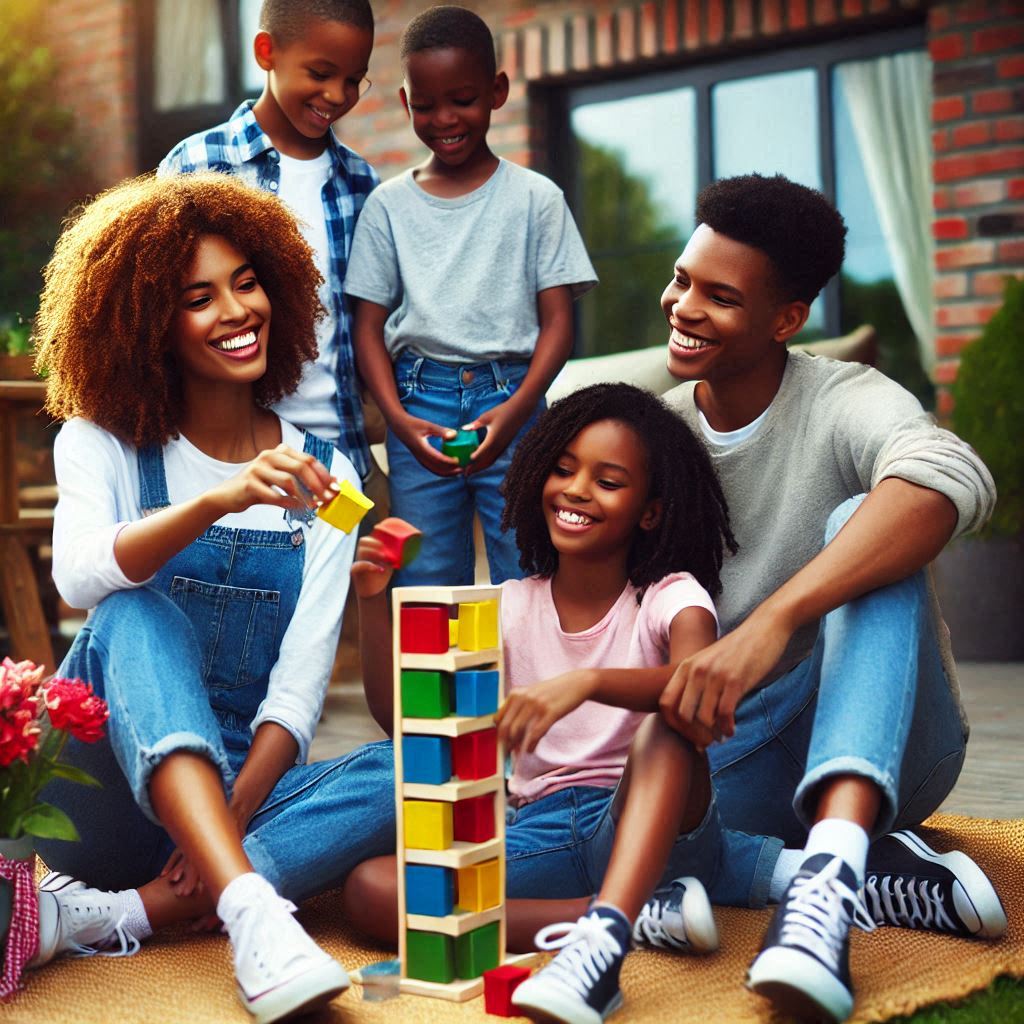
838,52,935,372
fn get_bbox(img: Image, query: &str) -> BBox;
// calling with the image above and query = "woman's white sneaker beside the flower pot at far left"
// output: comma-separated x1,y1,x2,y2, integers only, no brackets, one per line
28,871,139,968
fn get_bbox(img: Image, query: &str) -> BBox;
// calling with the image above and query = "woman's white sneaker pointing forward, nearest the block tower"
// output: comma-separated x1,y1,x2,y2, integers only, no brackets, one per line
217,874,348,1024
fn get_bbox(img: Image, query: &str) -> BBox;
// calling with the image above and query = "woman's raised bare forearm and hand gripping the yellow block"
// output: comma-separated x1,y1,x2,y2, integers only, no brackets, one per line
114,444,334,583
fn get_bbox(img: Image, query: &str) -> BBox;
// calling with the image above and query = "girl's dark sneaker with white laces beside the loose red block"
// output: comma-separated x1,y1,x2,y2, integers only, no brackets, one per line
512,906,630,1024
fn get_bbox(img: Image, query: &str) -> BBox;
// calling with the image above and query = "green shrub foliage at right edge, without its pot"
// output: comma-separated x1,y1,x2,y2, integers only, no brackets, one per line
952,278,1024,537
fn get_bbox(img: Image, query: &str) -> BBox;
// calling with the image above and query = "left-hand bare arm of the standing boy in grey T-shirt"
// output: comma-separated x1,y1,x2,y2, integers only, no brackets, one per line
353,299,462,476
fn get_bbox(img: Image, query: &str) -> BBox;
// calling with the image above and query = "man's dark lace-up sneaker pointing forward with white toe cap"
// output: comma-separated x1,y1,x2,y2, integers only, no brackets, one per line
746,853,874,1021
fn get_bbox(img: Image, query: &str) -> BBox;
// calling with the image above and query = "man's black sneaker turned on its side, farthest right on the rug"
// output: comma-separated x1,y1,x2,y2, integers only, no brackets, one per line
864,831,1007,939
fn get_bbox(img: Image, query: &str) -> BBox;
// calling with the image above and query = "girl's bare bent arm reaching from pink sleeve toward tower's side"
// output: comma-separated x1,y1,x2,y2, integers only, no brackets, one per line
496,607,716,752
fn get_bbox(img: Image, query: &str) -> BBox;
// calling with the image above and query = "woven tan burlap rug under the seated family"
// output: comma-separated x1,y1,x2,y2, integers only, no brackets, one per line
0,815,1024,1024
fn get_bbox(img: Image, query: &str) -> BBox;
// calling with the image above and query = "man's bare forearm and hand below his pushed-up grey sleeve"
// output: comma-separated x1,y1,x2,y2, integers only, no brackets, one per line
663,478,956,736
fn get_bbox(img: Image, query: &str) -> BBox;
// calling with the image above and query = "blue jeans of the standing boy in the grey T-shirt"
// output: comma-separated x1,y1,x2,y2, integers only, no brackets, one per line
387,352,545,587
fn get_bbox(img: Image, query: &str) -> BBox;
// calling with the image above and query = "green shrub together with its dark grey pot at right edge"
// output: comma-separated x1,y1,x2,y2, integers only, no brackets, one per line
935,278,1024,662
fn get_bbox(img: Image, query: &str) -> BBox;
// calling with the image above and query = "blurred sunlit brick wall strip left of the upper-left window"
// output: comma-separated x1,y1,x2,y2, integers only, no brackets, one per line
46,0,137,187
